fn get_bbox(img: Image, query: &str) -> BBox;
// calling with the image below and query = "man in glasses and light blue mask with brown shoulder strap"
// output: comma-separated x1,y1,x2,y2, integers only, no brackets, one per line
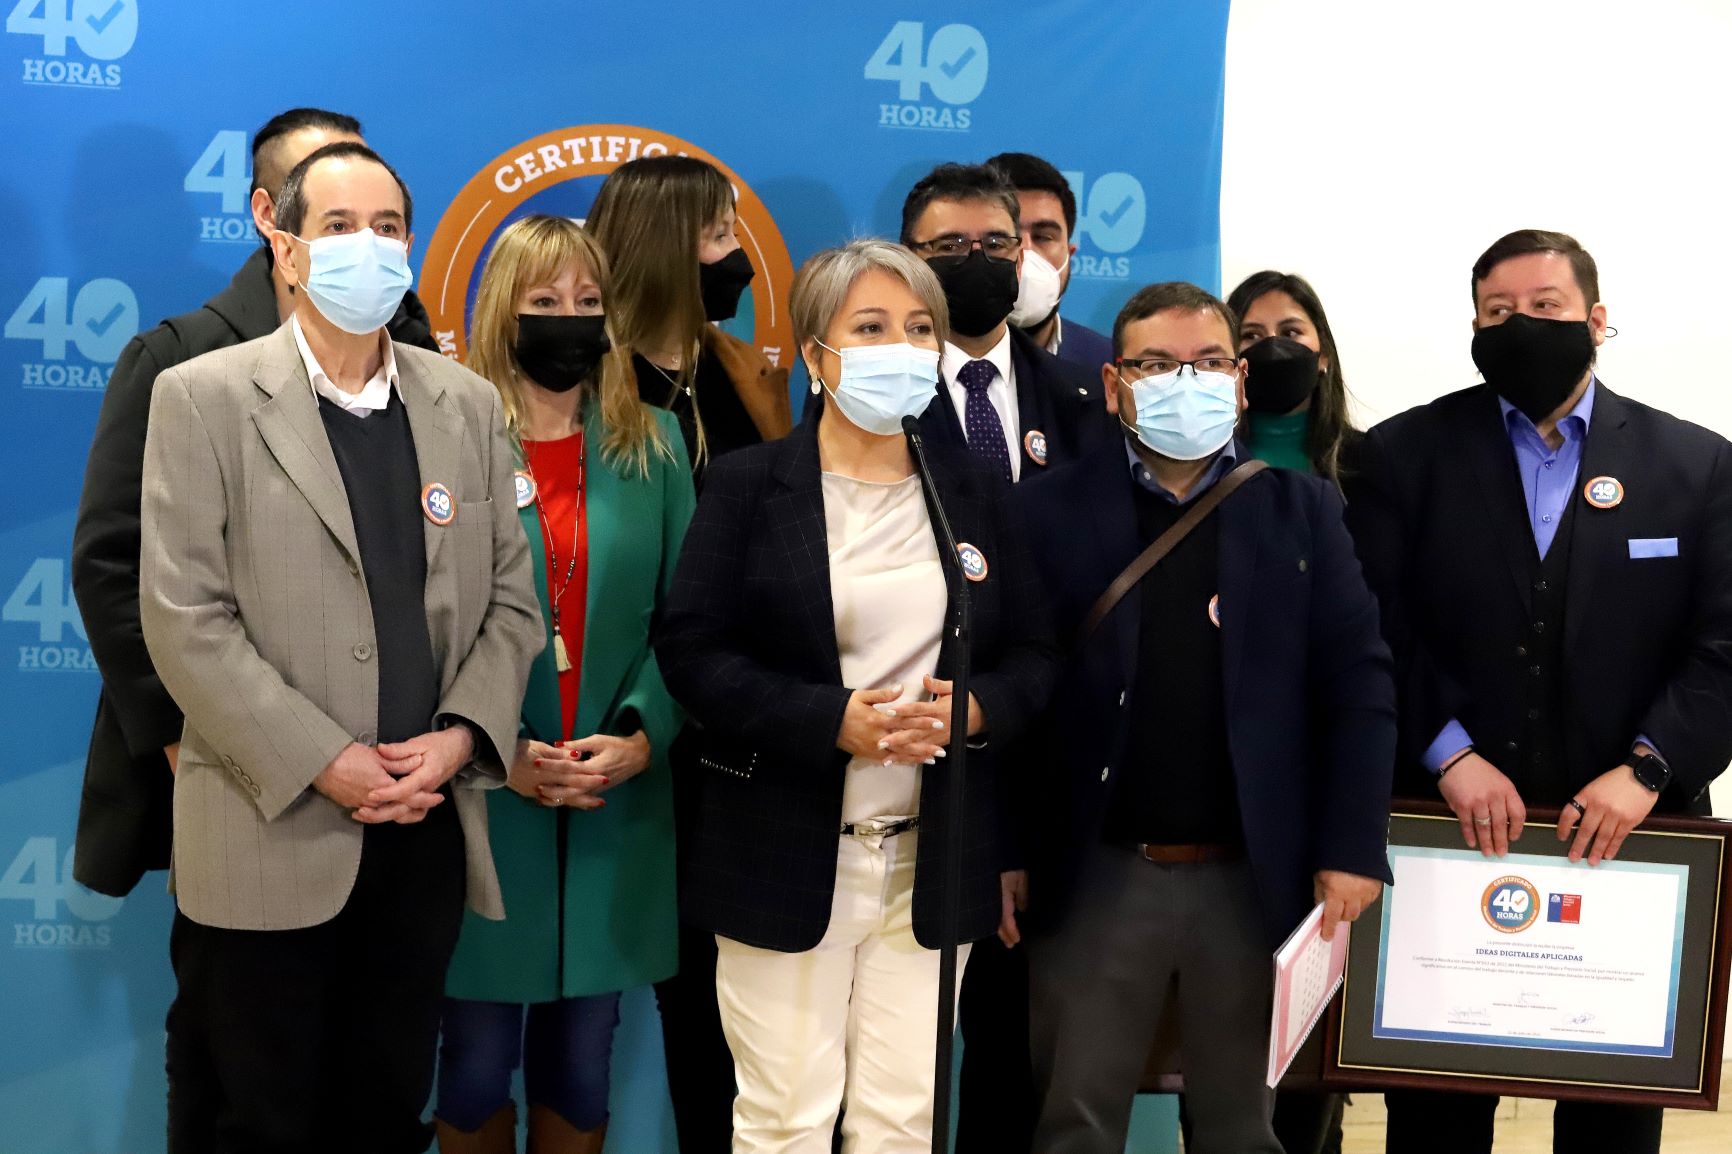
1017,282,1396,1154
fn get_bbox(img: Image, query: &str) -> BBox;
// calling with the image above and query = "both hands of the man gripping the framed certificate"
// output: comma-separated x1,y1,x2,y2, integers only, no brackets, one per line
1438,747,1659,865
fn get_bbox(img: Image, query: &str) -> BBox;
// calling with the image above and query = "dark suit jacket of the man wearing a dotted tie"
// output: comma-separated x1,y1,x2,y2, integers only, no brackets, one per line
920,326,1115,480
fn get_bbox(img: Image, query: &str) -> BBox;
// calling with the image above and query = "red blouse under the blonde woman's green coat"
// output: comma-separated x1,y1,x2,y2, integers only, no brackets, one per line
523,433,589,740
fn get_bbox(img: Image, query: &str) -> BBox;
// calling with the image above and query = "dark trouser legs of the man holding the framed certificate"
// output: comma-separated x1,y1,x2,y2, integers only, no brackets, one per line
1384,1090,1664,1154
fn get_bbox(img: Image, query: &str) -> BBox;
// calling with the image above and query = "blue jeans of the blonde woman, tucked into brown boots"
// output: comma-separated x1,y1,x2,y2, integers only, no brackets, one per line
433,993,620,1130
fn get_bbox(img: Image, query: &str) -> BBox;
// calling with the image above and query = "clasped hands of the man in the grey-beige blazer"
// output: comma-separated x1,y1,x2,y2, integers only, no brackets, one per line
313,726,475,825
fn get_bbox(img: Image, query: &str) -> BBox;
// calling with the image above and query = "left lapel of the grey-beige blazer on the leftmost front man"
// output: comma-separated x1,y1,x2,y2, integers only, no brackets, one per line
253,324,360,565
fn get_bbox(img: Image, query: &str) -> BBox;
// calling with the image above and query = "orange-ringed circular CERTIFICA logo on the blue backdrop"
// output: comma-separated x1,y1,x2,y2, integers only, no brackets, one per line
421,125,793,366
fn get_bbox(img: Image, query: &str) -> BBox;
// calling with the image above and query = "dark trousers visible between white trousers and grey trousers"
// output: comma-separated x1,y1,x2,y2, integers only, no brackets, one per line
956,937,1034,1154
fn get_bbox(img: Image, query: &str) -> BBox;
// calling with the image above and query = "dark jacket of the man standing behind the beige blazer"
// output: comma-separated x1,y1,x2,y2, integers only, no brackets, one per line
73,248,438,898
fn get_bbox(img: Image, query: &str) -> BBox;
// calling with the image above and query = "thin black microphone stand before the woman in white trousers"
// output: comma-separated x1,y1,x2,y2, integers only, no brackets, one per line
902,418,970,1154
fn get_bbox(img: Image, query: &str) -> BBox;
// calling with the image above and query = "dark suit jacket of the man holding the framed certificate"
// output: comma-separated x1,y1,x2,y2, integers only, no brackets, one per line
1349,381,1732,813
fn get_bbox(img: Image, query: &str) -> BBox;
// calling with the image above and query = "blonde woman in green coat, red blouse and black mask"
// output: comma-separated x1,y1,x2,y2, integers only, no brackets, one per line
435,217,695,1154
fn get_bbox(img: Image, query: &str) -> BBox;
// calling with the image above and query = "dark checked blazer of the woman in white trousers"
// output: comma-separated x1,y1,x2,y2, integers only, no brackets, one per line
655,404,1055,951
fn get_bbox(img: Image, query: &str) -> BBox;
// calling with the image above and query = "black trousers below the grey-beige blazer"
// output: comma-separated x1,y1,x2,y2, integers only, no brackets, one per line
168,802,464,1154
